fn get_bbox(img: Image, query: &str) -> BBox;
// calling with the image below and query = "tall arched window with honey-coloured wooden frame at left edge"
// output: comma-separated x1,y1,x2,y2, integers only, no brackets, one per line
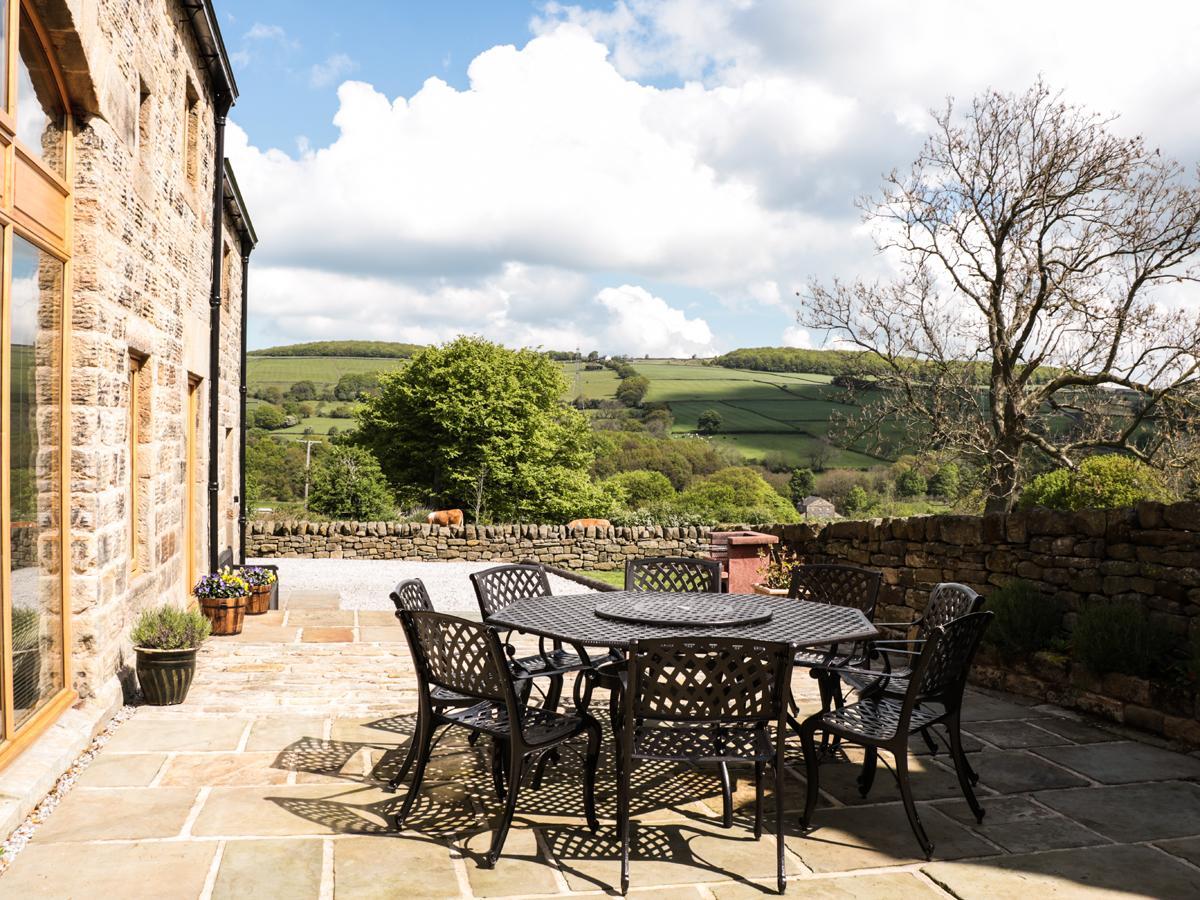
0,0,74,766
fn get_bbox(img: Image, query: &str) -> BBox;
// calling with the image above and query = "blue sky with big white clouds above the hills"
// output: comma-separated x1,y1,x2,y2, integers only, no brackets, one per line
217,0,1200,356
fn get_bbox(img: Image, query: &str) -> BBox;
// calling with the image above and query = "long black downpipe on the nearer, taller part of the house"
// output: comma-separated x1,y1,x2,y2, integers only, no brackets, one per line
209,90,233,572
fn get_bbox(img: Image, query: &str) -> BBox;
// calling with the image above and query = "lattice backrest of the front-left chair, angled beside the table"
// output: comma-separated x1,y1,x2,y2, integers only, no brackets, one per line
400,610,516,707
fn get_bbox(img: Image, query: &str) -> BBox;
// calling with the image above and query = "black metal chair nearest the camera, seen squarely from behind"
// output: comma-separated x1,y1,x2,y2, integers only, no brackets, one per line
617,637,792,894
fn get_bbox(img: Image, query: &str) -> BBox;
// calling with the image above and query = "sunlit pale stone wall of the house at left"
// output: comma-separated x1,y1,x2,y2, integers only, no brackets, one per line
67,0,241,700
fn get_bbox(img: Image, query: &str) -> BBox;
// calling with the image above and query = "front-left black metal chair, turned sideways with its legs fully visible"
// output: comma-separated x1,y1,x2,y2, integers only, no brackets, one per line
396,610,600,868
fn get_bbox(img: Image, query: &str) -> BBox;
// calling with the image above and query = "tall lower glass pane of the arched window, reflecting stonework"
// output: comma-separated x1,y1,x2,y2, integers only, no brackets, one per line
8,235,62,727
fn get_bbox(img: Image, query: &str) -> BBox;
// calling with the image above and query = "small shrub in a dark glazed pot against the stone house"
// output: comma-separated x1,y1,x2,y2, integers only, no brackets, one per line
130,606,212,707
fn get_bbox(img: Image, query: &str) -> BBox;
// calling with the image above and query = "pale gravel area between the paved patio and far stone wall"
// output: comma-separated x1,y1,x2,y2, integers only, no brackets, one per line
251,559,588,612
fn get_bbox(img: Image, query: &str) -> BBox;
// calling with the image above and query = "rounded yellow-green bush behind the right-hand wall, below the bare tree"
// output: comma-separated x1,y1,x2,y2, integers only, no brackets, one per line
1020,454,1172,510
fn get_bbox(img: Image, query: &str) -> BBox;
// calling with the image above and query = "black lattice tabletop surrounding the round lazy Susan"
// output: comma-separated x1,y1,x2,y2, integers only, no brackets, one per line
488,590,878,649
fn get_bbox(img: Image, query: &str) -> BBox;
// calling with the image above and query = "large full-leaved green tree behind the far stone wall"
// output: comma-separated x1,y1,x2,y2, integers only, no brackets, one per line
355,337,612,521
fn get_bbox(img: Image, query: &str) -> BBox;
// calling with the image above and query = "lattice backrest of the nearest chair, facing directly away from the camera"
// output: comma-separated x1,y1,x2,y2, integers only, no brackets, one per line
625,637,793,722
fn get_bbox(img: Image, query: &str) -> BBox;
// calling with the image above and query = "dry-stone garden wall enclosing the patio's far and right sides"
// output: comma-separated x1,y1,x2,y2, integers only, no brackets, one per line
248,503,1200,746
